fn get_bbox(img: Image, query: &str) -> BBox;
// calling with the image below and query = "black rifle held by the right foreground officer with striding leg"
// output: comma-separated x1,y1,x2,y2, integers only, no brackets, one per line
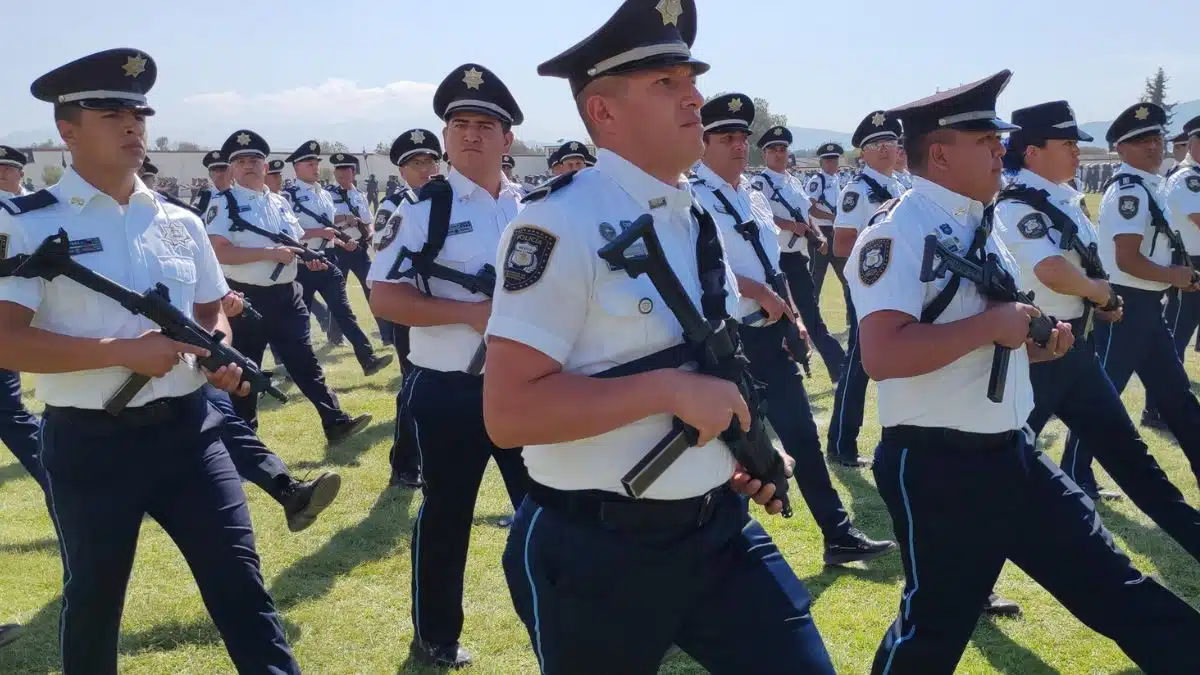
920,234,1057,404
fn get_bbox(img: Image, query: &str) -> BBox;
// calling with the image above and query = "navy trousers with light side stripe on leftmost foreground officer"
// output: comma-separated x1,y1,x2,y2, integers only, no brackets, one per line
42,392,300,675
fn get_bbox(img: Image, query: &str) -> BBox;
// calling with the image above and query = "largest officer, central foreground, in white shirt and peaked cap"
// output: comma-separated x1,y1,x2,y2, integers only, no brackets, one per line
484,0,833,674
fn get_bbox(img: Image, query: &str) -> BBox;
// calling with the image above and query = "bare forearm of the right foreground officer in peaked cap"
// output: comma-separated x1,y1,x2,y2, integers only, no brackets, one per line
858,310,996,382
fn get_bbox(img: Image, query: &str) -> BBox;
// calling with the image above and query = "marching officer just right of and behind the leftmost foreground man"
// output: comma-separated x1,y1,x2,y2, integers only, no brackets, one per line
205,130,371,443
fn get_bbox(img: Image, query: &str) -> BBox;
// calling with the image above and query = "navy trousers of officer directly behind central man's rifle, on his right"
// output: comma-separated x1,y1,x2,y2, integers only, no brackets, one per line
738,323,851,540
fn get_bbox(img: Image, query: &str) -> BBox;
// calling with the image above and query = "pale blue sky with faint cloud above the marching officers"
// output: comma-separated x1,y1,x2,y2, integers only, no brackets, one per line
0,0,1200,149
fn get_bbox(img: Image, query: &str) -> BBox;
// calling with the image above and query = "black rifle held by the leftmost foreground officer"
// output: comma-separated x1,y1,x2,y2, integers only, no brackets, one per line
5,229,288,416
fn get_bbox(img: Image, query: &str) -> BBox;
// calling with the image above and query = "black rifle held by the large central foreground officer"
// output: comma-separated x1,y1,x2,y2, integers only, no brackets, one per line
599,214,792,518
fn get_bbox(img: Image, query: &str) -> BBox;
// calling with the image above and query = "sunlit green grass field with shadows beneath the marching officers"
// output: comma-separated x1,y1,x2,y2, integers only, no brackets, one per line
0,196,1200,675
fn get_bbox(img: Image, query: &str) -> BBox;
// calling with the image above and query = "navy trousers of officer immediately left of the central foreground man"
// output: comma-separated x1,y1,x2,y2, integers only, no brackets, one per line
408,368,528,645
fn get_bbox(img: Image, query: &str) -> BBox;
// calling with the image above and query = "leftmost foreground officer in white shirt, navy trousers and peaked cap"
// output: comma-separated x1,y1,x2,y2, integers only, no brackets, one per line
0,49,300,674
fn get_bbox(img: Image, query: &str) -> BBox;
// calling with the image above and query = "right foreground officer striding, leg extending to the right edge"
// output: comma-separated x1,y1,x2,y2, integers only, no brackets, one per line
847,71,1200,675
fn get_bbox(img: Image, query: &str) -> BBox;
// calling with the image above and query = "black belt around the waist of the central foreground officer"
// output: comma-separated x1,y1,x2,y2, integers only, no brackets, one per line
529,480,732,530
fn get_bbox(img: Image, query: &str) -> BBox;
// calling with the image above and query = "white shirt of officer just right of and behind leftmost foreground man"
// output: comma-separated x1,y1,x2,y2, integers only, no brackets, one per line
205,185,304,286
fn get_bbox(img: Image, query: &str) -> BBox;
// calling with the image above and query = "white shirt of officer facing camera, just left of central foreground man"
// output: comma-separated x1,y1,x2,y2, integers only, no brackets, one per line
367,169,520,372
